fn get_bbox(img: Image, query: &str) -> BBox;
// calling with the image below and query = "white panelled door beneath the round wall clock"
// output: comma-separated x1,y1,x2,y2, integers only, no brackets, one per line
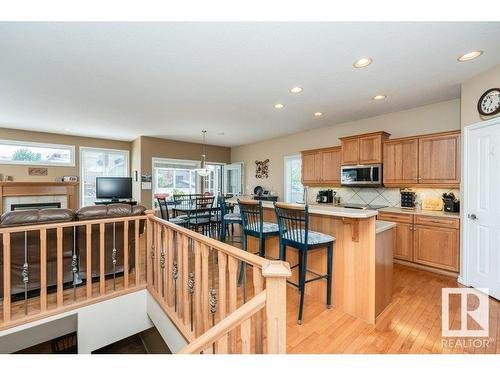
462,119,500,299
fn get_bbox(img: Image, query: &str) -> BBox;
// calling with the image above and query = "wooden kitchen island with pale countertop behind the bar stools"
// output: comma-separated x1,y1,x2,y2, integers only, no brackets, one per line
228,198,395,324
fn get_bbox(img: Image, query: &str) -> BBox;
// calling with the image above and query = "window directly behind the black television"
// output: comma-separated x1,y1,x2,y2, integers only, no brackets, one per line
80,147,129,207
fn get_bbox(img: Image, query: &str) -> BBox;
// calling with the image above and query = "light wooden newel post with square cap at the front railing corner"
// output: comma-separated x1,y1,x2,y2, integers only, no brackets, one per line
262,260,292,354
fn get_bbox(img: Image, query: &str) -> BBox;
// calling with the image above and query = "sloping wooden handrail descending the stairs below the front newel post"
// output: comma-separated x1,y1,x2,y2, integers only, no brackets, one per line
179,291,267,354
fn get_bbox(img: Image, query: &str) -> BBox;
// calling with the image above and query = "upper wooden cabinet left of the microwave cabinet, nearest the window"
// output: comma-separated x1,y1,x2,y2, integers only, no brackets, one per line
302,147,341,186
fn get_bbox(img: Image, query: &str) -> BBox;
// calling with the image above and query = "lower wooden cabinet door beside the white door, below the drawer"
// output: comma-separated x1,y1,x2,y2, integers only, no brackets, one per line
414,225,460,272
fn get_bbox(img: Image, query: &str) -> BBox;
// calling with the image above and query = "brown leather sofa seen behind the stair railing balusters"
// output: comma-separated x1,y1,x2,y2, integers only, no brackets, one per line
0,203,146,298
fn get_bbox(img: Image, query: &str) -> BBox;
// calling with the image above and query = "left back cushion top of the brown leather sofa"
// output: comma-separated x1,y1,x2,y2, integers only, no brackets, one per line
0,208,75,227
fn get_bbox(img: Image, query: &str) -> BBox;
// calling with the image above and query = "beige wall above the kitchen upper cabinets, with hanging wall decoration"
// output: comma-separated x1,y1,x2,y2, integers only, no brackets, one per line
231,99,460,200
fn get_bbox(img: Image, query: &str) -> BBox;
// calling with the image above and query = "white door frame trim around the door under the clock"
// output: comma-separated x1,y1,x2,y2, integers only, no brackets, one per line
458,117,500,286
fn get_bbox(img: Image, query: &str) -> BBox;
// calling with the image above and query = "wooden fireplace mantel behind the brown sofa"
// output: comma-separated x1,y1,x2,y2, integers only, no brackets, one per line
0,181,78,214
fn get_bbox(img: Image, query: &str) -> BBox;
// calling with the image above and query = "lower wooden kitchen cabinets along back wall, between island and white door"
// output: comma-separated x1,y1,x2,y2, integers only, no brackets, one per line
377,212,460,272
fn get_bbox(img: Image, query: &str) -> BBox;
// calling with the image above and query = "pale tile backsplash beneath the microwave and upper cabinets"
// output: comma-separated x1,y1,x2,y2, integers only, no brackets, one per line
308,187,460,207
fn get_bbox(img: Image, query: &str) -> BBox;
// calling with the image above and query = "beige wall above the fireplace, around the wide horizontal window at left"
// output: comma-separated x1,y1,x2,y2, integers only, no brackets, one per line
0,128,131,204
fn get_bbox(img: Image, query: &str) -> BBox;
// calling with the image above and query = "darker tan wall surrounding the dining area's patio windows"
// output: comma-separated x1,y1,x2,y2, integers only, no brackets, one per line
137,137,231,208
